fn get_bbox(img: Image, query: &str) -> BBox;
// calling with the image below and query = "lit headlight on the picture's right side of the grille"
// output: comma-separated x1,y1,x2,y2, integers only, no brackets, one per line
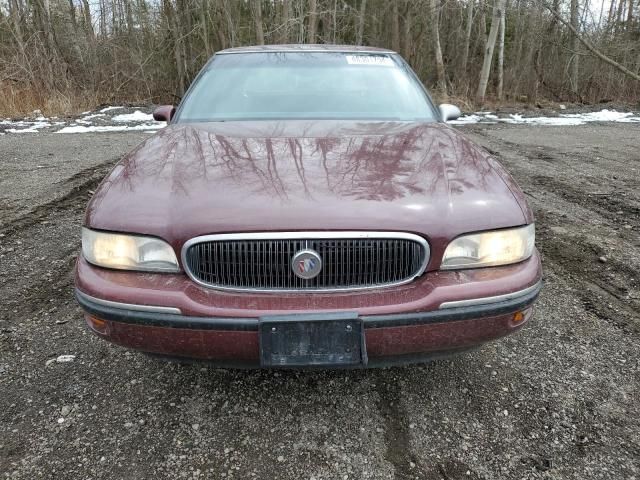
441,223,536,270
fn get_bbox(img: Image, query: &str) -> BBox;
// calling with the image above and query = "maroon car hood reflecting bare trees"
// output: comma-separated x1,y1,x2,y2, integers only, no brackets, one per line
85,121,530,255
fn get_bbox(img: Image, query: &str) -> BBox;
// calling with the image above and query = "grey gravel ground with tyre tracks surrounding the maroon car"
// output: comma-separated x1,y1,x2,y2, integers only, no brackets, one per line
0,124,640,480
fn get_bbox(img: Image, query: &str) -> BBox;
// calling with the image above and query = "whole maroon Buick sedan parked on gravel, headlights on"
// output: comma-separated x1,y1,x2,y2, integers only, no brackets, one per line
76,46,541,367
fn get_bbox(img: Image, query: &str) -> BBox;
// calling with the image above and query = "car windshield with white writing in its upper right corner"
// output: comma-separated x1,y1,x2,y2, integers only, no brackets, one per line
176,52,436,122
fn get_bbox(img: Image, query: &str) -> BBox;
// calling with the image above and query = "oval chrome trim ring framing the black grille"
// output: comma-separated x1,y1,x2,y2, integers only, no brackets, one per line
180,231,431,294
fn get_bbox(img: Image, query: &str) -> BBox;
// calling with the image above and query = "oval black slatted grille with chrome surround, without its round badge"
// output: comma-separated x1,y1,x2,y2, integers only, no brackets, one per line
182,232,429,291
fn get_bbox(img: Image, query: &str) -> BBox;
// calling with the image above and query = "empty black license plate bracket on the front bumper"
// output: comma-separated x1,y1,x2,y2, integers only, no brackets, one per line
259,312,367,367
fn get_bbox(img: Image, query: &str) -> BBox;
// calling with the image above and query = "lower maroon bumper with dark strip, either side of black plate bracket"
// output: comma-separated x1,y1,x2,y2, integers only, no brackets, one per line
76,278,542,366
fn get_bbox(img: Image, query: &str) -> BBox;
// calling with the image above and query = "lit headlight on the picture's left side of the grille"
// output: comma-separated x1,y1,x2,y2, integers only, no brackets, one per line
82,227,180,272
